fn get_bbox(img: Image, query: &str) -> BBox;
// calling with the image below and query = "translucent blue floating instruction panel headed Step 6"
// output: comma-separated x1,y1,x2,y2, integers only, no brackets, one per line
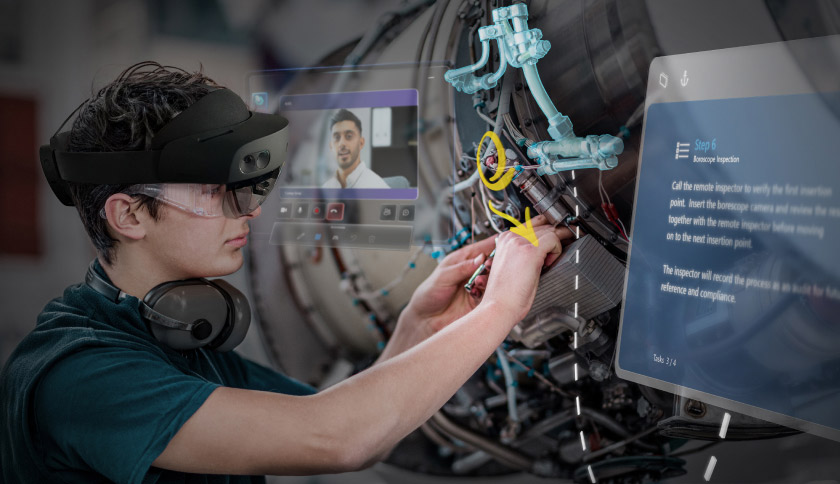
616,34,840,439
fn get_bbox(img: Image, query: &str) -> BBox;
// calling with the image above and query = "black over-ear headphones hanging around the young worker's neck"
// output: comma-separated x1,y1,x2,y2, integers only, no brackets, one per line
85,259,251,352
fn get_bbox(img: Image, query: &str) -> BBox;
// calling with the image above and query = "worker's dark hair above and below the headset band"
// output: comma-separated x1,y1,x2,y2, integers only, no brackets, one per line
68,61,218,264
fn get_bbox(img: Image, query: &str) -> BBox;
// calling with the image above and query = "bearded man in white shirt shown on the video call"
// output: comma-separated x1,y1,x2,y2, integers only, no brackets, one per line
321,109,389,188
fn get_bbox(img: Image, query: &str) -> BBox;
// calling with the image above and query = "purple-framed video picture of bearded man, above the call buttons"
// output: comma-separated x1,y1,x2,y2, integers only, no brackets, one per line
278,89,418,200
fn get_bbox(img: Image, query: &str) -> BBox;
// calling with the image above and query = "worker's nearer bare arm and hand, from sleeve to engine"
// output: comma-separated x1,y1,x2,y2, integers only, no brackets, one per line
153,227,560,475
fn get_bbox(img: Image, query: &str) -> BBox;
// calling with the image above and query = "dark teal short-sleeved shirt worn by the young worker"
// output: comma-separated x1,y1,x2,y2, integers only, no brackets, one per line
0,264,315,484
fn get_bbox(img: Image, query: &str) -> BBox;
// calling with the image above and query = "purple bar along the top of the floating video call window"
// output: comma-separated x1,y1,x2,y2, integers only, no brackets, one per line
280,89,418,113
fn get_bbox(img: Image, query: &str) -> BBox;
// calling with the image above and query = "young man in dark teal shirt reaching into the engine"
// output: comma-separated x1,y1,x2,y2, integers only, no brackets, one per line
0,63,571,483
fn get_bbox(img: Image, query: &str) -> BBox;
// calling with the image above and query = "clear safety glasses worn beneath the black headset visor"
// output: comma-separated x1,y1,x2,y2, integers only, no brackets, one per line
120,168,280,218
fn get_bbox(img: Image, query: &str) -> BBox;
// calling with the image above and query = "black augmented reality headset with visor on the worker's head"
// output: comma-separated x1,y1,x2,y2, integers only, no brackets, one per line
40,88,289,217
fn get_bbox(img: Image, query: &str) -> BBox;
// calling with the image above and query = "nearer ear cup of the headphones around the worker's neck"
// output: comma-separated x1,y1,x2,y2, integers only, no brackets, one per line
143,279,228,350
